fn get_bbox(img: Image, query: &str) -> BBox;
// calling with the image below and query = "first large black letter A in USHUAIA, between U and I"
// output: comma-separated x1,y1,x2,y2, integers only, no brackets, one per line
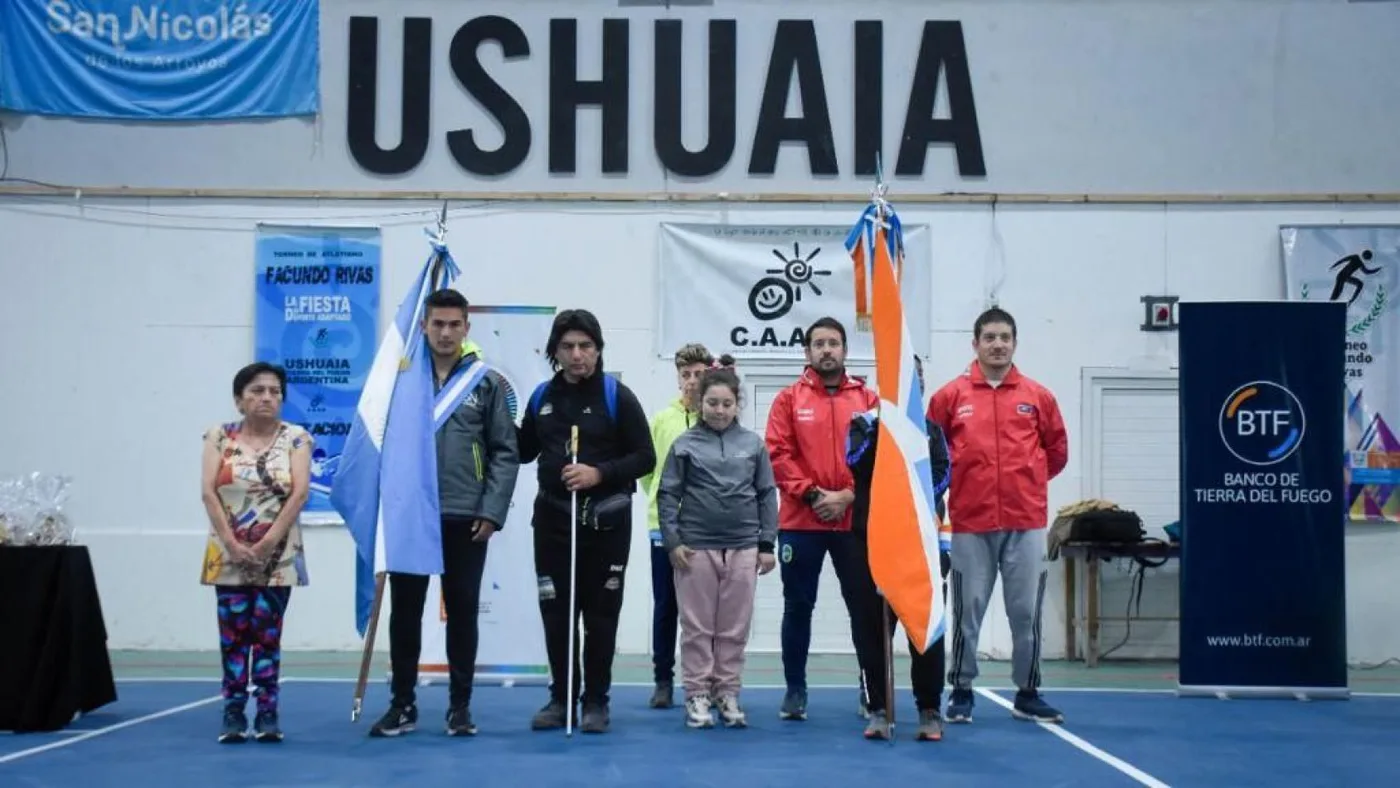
749,20,837,175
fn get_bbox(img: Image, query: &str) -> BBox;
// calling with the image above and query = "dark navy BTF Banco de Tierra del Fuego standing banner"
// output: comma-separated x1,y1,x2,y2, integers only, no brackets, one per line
1180,302,1347,697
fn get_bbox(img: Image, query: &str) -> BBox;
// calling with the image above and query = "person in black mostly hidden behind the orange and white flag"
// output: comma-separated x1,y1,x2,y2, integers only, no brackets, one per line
847,397,949,740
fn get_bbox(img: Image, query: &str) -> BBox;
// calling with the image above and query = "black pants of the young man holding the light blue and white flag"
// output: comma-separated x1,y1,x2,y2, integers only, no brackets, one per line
389,518,489,707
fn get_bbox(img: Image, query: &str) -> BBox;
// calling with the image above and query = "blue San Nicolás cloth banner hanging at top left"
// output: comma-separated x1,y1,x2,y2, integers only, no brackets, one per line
0,0,321,120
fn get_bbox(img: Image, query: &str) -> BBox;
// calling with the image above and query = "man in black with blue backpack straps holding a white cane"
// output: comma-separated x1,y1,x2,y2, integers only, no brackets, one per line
519,309,657,733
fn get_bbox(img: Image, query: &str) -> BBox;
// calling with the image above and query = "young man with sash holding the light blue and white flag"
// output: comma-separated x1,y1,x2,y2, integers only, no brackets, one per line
370,290,519,736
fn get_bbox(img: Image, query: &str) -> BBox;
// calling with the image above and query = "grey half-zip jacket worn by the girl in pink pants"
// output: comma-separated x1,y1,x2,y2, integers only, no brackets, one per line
657,421,778,553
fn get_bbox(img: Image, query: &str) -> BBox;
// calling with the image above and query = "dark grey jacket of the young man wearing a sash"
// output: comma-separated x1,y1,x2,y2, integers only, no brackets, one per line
437,353,519,530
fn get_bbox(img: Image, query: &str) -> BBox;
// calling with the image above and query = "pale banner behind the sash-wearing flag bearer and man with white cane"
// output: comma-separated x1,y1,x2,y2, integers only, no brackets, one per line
419,307,554,684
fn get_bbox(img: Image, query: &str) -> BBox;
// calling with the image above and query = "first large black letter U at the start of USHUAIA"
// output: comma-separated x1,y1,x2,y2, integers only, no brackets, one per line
346,17,433,175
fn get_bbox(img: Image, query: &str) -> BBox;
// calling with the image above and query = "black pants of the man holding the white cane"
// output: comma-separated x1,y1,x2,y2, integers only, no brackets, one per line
535,502,631,705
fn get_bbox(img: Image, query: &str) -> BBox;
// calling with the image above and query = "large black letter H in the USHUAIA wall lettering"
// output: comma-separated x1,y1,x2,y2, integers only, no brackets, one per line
549,20,629,175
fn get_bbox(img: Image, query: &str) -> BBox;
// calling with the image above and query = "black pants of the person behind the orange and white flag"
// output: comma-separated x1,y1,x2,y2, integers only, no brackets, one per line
854,533,949,712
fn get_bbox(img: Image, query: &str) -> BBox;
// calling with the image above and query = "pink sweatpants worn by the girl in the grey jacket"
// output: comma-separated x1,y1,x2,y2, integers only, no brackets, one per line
675,547,759,698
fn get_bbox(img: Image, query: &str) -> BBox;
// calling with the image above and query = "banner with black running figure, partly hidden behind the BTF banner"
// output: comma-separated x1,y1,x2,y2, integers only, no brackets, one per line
1281,224,1400,523
